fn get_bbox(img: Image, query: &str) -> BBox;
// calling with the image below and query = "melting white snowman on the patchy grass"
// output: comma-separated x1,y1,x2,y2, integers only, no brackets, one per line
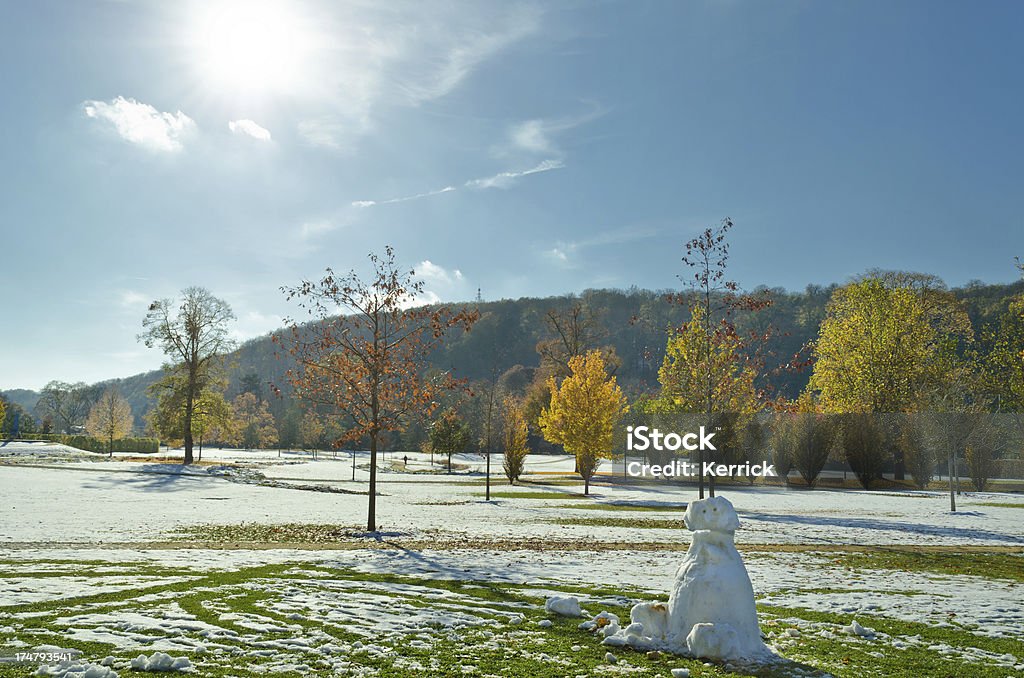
616,497,770,661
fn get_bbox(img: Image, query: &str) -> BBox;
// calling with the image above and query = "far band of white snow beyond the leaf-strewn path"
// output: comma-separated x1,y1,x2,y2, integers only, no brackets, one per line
0,451,1024,546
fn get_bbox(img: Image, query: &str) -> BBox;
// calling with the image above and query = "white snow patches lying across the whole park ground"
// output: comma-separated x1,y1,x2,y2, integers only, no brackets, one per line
0,446,1024,672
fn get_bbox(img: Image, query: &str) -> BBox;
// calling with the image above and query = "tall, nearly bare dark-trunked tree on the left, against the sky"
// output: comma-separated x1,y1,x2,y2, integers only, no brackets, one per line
139,287,234,464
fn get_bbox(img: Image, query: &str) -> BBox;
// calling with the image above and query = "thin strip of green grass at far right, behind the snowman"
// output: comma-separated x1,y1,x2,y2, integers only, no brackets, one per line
829,550,1024,582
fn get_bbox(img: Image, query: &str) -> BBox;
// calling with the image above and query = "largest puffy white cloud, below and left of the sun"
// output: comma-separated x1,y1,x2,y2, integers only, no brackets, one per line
82,96,196,153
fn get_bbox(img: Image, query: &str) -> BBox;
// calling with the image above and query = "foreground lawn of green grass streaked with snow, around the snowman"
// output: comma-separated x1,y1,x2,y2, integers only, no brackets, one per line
0,560,1024,678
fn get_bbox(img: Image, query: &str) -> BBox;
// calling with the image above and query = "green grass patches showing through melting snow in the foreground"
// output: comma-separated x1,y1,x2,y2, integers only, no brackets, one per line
0,553,1024,678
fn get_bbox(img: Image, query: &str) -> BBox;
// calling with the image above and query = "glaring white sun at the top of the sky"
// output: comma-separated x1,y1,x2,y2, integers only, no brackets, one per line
190,0,316,94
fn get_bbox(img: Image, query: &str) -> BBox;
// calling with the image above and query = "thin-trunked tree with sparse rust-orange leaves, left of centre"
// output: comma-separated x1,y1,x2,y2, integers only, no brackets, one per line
275,247,477,532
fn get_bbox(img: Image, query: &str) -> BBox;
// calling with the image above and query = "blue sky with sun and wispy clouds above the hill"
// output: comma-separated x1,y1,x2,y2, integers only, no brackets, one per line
0,0,1024,388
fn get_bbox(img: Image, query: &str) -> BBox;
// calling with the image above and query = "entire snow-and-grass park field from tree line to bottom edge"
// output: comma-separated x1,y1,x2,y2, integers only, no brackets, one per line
0,443,1024,676
